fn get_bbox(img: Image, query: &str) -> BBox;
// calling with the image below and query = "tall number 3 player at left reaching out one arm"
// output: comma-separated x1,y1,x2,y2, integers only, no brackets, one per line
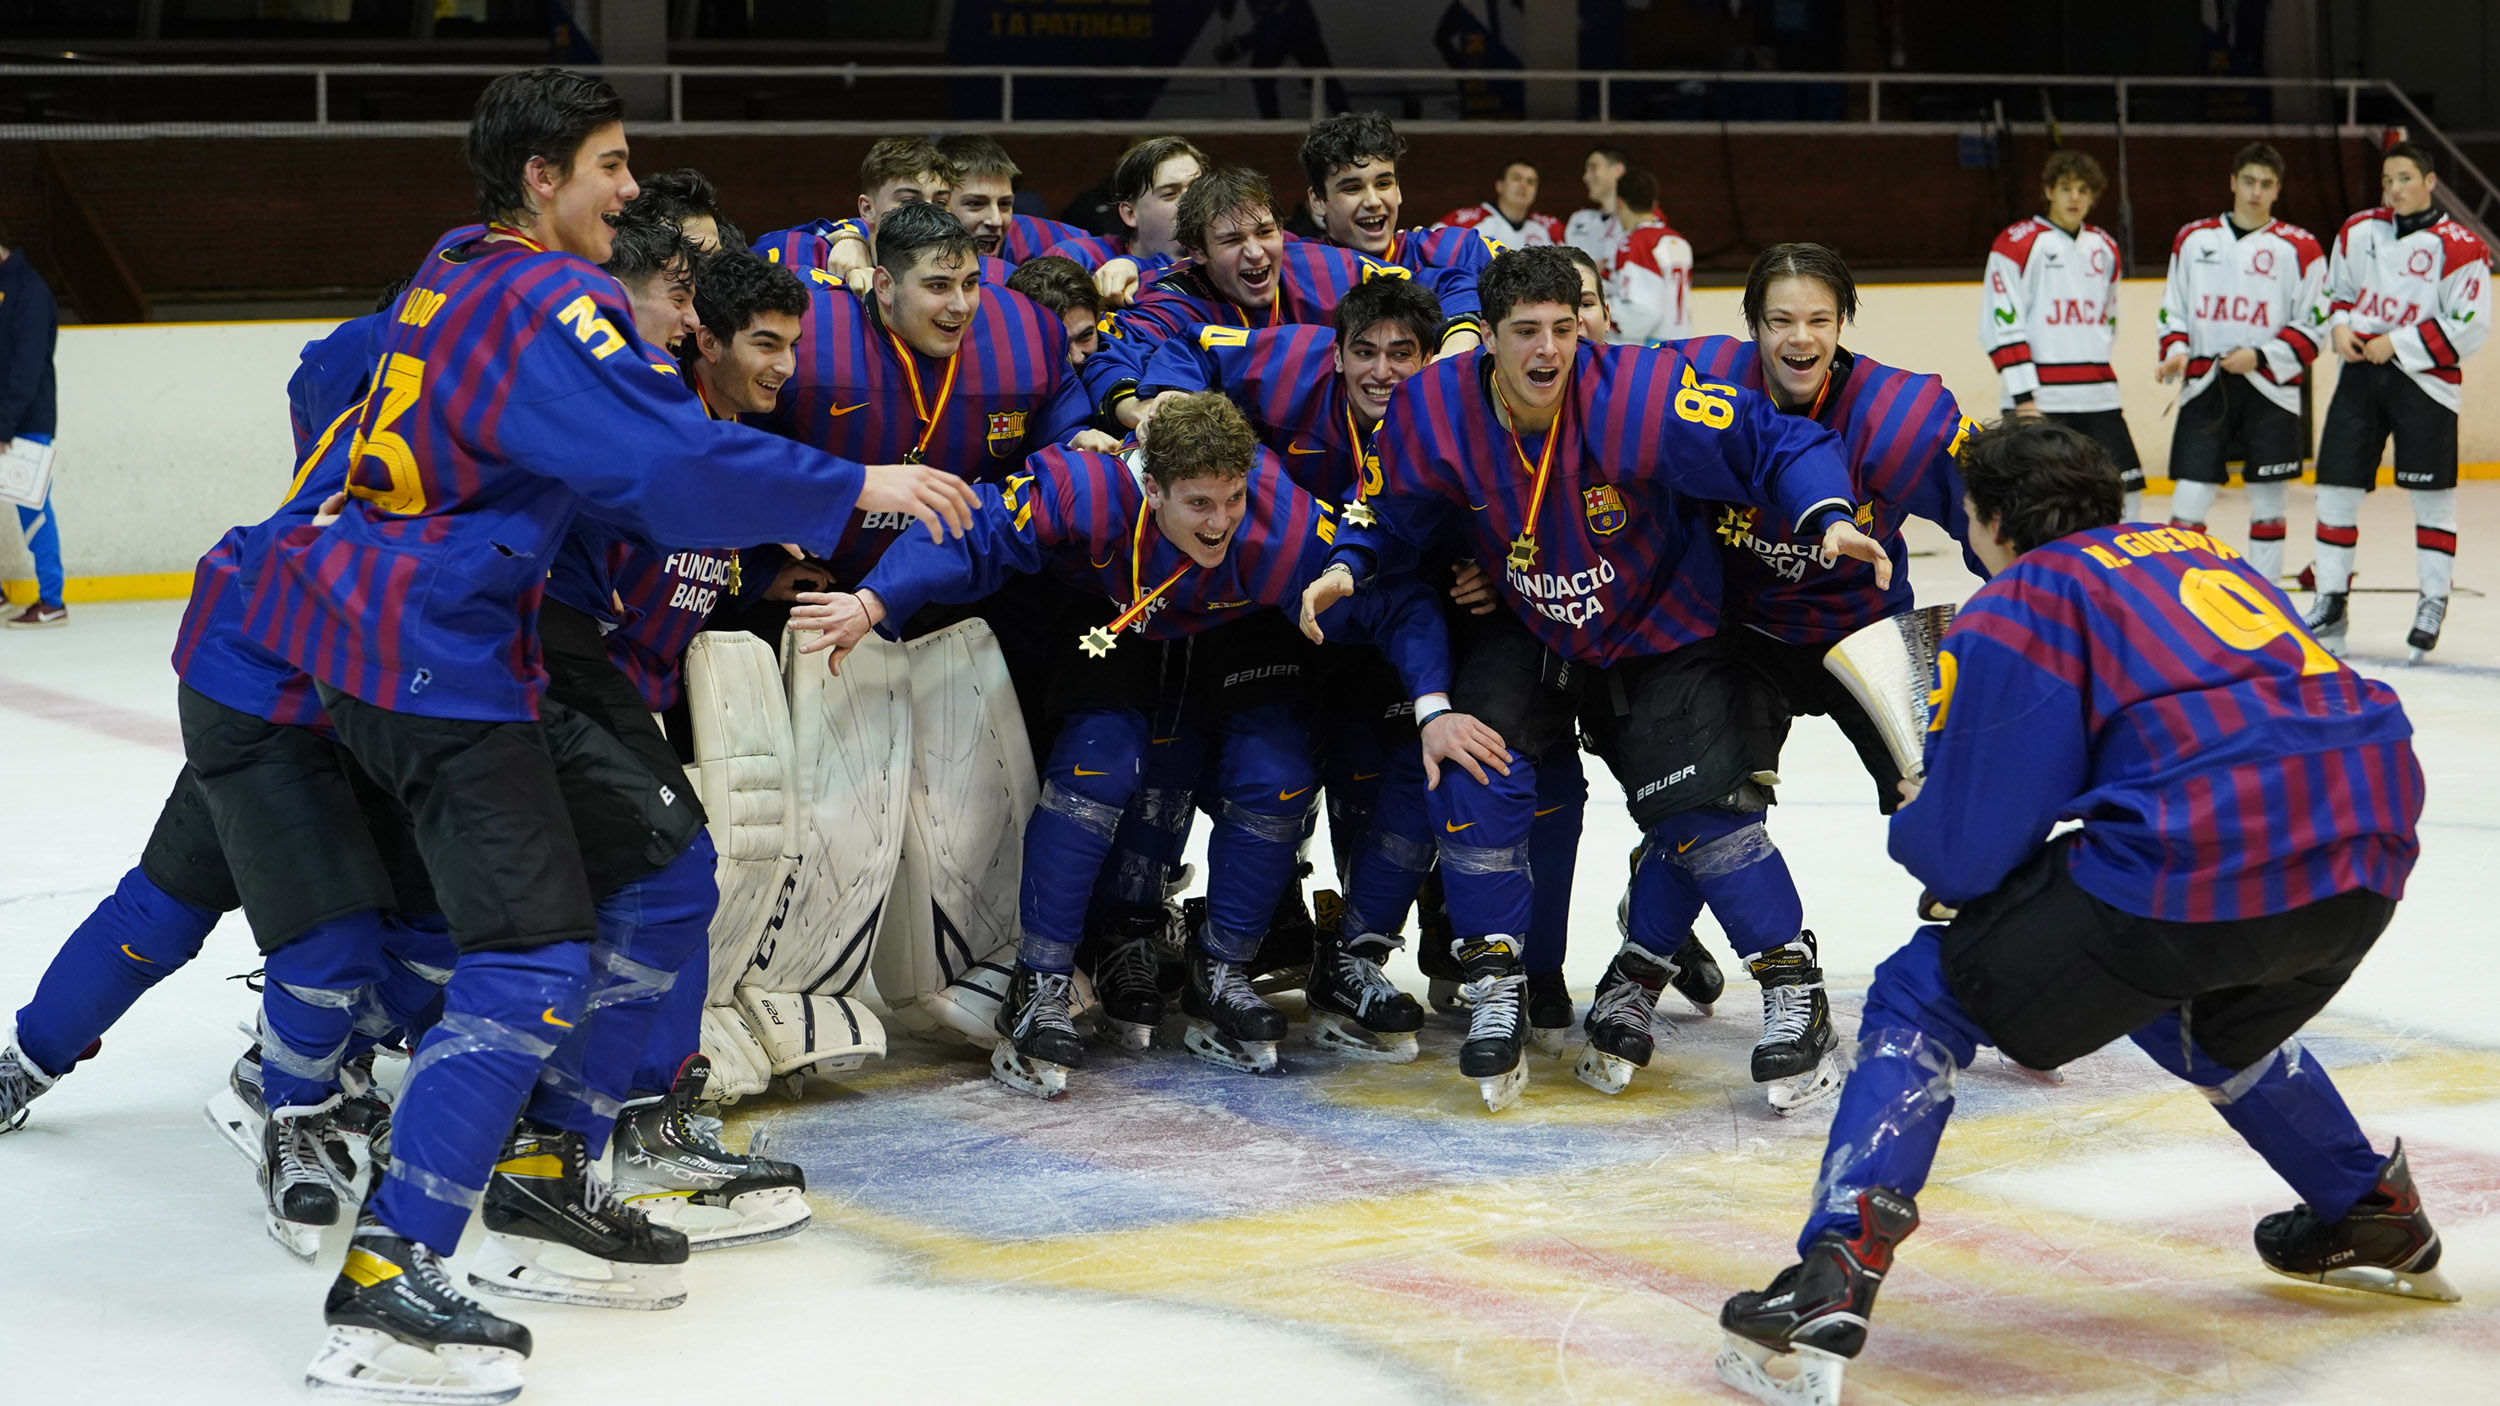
245,70,965,1401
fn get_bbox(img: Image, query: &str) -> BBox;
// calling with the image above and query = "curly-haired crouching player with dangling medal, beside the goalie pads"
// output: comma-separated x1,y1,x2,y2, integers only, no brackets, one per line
790,393,1470,1098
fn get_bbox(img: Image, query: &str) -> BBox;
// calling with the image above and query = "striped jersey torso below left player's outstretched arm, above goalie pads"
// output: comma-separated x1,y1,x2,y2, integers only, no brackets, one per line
548,518,740,713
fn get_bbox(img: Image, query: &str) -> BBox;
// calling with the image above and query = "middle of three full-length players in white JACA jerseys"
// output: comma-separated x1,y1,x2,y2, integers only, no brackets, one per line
2155,143,2320,580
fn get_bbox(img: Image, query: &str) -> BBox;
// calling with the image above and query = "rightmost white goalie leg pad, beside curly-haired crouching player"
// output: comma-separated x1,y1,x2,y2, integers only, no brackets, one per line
870,620,1040,1043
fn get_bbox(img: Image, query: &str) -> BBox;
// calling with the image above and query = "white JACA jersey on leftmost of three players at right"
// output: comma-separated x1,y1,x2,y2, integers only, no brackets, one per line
1980,215,2118,413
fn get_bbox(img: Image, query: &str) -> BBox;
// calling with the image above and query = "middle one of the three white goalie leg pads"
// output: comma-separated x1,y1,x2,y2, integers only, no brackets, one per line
770,622,913,995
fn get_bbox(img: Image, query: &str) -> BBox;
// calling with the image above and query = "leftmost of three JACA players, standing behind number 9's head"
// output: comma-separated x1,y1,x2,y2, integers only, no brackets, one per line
1980,150,2145,523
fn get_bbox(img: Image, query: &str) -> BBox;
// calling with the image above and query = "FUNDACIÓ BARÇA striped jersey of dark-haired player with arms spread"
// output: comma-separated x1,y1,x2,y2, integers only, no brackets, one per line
1338,343,1850,663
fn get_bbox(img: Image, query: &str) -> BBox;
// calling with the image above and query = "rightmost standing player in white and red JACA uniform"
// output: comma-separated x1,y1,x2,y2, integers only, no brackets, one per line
2308,143,2493,663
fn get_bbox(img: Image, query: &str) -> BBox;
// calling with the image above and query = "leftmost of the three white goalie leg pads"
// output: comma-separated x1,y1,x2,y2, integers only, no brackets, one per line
685,630,798,1000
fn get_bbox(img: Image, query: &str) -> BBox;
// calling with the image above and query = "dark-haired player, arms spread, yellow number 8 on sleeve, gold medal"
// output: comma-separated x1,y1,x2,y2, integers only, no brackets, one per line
1305,248,1893,1111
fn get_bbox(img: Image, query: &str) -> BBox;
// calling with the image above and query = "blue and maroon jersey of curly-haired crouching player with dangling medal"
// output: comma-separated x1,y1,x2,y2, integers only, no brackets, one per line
860,448,1450,698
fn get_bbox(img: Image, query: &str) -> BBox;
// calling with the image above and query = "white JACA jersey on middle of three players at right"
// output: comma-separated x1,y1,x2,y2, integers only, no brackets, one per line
2155,215,2328,415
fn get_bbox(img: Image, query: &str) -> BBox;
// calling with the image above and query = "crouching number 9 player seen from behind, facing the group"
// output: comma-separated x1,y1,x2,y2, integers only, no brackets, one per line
1720,420,2455,1406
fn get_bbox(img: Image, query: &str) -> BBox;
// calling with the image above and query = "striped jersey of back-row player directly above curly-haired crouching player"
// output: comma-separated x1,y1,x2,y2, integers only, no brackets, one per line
1078,240,1478,410
